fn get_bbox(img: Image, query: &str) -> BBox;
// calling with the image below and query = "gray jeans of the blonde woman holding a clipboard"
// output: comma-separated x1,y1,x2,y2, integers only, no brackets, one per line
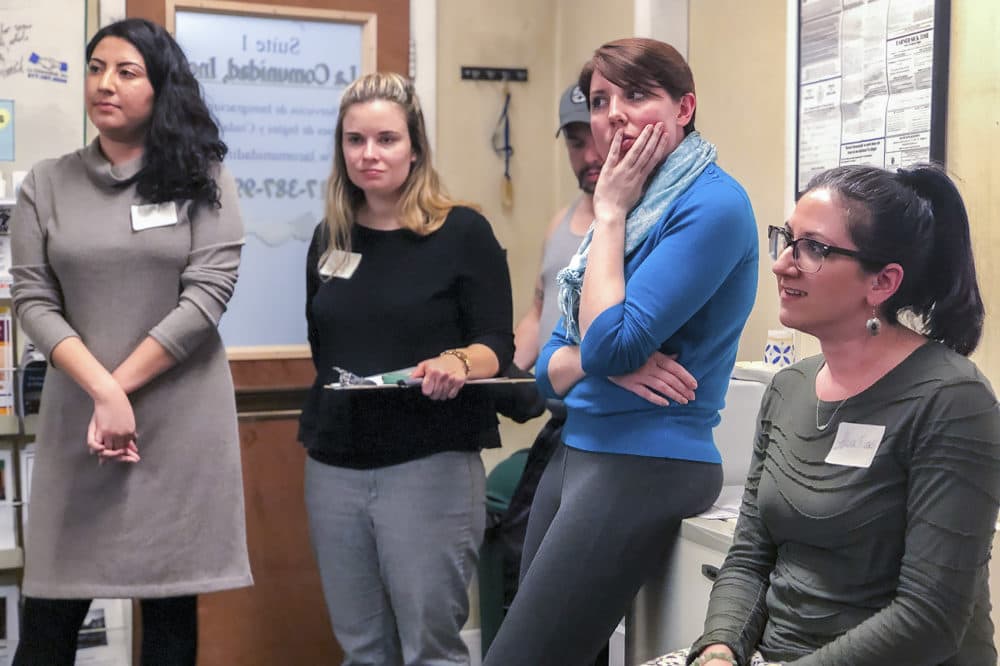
305,451,486,666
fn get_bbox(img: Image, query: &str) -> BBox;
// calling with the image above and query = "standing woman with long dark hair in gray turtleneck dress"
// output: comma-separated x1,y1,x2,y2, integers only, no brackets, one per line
11,19,252,666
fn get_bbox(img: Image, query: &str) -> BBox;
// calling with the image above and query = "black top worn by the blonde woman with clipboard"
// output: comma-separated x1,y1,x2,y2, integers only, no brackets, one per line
299,206,514,469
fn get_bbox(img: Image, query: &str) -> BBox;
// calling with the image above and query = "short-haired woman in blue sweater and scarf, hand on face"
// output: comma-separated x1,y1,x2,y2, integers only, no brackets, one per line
486,39,757,666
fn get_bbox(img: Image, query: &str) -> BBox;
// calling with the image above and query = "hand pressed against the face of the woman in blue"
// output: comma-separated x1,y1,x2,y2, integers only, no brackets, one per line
594,123,669,222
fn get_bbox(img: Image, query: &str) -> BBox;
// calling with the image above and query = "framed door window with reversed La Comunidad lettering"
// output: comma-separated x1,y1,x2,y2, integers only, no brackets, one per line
167,0,376,352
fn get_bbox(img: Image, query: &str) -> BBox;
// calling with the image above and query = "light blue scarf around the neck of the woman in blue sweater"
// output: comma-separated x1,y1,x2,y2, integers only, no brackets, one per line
556,132,715,344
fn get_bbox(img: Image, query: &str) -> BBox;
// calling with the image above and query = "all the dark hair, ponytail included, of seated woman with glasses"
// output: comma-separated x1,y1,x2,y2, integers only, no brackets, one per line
806,165,985,356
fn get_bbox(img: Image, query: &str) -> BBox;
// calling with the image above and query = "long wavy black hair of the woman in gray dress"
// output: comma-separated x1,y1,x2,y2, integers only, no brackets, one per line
87,18,228,214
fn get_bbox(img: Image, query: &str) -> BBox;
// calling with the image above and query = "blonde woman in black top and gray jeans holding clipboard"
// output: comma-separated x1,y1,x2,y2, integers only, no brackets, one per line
300,74,513,665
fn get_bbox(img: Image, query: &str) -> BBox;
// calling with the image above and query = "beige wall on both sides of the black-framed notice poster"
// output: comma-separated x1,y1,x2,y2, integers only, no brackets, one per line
689,0,1000,384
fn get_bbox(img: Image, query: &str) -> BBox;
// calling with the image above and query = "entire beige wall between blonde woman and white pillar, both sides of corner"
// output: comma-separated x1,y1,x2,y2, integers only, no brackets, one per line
436,0,632,469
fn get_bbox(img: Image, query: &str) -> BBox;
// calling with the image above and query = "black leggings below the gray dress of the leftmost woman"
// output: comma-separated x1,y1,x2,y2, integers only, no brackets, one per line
14,596,198,666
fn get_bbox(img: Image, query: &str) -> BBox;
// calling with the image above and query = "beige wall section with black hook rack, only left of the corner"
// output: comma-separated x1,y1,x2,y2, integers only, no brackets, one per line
436,0,556,332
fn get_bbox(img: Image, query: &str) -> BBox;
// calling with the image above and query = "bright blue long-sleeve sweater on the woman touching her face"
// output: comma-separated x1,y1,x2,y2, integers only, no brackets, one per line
536,164,758,463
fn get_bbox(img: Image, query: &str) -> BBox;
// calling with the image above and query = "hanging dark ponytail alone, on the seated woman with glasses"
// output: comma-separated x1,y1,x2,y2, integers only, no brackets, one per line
896,165,985,356
